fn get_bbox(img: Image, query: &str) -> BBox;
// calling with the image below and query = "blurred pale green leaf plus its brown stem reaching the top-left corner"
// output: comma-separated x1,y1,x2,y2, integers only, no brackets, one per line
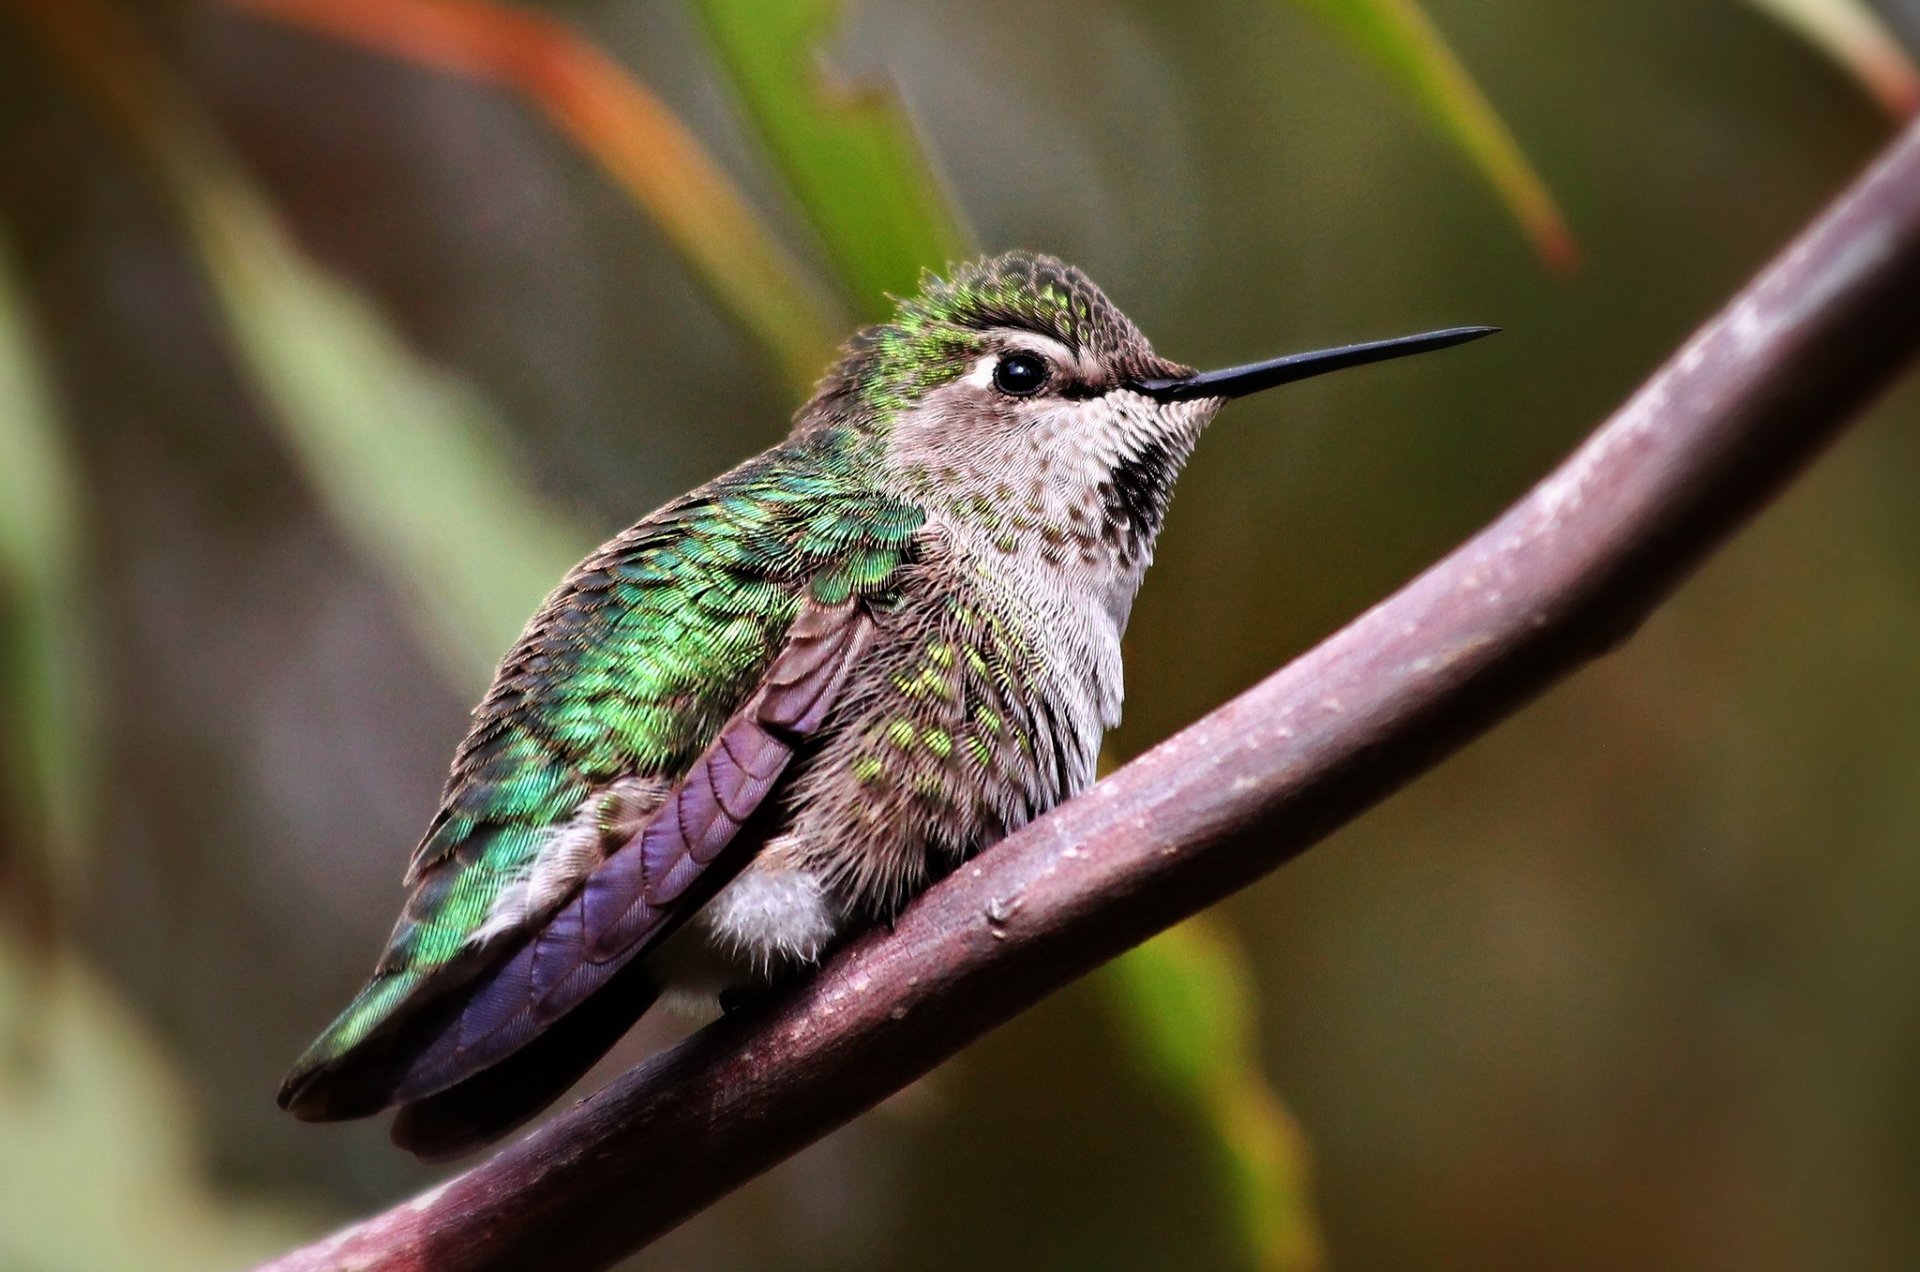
13,0,591,684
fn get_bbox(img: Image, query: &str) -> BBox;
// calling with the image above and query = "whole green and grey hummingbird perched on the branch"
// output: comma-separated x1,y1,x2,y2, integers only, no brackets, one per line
280,252,1494,1159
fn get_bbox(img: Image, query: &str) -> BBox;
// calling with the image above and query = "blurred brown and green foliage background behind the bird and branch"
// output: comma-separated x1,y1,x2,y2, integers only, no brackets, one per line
0,0,1920,1272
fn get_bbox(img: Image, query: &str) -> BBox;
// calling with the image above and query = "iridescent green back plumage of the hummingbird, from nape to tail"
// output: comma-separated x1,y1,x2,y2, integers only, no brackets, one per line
296,428,925,1072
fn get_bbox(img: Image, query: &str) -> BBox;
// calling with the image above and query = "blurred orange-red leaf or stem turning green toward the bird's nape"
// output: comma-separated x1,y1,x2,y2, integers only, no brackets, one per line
223,0,845,396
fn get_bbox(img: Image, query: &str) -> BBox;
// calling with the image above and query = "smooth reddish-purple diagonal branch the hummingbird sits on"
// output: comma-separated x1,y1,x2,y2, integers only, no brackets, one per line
271,129,1920,1272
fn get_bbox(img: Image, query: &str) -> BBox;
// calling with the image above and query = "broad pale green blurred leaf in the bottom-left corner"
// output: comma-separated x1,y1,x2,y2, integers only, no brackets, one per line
0,932,315,1272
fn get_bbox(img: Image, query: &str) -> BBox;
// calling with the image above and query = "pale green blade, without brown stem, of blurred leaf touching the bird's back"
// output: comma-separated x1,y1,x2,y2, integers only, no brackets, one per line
192,209,591,684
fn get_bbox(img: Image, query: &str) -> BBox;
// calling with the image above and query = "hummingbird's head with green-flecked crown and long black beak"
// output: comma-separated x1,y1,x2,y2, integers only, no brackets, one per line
801,252,1492,591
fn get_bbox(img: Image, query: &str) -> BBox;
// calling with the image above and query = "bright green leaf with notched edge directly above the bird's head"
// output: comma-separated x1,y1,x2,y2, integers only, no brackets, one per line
693,0,972,319
